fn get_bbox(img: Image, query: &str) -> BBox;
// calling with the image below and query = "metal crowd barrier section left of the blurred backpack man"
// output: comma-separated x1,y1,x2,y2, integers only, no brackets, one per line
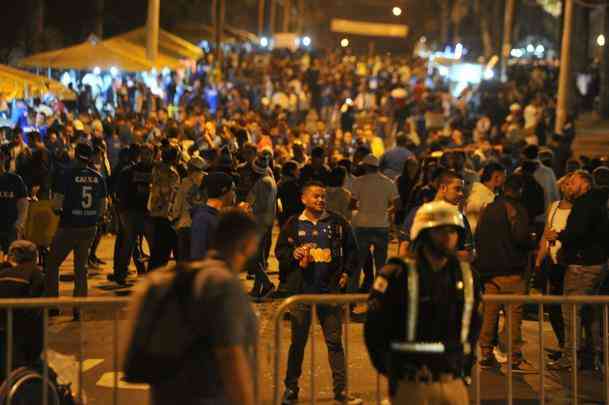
0,297,129,405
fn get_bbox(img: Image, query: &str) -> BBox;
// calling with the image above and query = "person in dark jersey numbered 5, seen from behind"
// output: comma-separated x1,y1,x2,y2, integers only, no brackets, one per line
46,143,108,318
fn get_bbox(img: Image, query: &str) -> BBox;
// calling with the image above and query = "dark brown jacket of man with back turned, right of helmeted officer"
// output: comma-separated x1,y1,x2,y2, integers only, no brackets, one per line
474,197,535,279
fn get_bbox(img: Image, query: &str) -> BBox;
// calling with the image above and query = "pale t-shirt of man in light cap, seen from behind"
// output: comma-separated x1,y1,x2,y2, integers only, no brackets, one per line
352,173,398,228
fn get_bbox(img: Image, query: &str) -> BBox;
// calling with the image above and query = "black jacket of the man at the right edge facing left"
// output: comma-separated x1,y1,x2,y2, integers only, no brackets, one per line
558,189,609,266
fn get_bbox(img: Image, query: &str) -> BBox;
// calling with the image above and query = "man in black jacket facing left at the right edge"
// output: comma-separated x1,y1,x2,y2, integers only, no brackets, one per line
546,170,609,370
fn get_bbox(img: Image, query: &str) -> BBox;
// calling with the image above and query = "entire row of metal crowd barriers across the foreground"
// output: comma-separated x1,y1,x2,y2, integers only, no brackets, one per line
0,294,609,405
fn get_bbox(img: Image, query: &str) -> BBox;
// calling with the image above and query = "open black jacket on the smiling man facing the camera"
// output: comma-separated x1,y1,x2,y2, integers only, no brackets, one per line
275,211,358,294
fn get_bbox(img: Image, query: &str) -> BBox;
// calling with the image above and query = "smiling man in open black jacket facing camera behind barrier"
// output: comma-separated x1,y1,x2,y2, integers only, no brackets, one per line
275,182,362,405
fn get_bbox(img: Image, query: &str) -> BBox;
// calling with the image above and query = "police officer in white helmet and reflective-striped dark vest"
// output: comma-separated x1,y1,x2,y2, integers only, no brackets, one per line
364,201,481,405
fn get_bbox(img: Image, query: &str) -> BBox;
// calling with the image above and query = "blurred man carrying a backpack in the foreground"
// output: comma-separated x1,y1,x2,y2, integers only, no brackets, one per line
124,210,259,405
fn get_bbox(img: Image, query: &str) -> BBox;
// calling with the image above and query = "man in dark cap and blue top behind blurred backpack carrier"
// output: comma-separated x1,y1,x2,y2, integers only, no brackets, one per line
190,172,237,260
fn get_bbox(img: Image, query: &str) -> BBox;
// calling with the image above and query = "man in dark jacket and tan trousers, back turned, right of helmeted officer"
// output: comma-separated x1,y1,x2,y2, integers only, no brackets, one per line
474,174,535,373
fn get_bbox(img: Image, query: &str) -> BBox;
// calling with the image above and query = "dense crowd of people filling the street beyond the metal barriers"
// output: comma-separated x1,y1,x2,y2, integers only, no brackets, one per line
0,48,609,404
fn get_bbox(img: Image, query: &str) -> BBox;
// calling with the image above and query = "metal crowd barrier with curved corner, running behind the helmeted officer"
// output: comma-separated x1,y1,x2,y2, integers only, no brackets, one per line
273,294,609,405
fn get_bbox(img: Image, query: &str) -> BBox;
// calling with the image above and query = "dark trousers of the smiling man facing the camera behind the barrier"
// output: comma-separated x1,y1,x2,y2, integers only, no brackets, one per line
285,304,346,394
